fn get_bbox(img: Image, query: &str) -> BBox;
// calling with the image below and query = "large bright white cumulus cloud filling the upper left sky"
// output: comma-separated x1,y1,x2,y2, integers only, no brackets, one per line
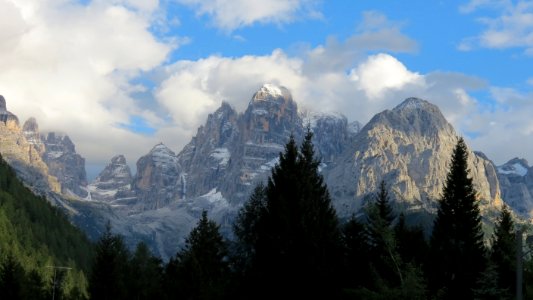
0,0,174,173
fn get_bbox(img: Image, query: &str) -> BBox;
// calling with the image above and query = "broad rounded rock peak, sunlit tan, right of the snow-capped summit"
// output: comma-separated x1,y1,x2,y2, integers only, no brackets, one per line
327,98,501,216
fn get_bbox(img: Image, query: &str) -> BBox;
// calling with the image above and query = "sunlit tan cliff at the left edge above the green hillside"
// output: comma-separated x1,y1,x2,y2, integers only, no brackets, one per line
0,96,61,194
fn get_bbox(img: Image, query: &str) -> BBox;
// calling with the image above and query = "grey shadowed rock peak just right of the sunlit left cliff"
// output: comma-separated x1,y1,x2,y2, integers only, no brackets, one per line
41,132,87,198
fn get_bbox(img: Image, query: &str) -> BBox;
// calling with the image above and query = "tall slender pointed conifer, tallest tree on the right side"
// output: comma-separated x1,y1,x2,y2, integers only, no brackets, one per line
428,138,486,299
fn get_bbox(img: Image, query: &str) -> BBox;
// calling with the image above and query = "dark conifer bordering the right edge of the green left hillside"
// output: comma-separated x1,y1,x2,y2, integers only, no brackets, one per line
89,224,129,300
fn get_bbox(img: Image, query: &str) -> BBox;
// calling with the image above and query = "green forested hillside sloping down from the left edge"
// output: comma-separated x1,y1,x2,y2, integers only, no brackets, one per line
0,157,94,299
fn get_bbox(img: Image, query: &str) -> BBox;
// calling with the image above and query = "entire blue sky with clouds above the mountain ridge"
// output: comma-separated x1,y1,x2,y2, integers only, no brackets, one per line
0,0,533,176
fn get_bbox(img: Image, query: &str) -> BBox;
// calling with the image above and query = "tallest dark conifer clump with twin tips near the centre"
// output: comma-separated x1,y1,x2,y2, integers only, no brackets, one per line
244,129,341,298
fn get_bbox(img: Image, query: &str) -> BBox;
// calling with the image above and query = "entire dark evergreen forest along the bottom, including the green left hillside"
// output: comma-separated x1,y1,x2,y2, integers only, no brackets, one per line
0,130,533,299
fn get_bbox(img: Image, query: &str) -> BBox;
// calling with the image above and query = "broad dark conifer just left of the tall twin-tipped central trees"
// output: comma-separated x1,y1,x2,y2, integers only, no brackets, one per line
165,211,229,299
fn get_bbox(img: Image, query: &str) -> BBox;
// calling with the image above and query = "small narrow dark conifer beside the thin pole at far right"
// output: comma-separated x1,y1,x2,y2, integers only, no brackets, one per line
490,205,516,298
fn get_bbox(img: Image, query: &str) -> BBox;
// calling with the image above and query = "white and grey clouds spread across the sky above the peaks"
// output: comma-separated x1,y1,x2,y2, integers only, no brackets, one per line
0,0,533,176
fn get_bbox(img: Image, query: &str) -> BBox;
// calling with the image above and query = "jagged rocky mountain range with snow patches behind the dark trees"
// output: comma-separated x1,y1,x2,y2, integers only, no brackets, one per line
0,84,533,258
